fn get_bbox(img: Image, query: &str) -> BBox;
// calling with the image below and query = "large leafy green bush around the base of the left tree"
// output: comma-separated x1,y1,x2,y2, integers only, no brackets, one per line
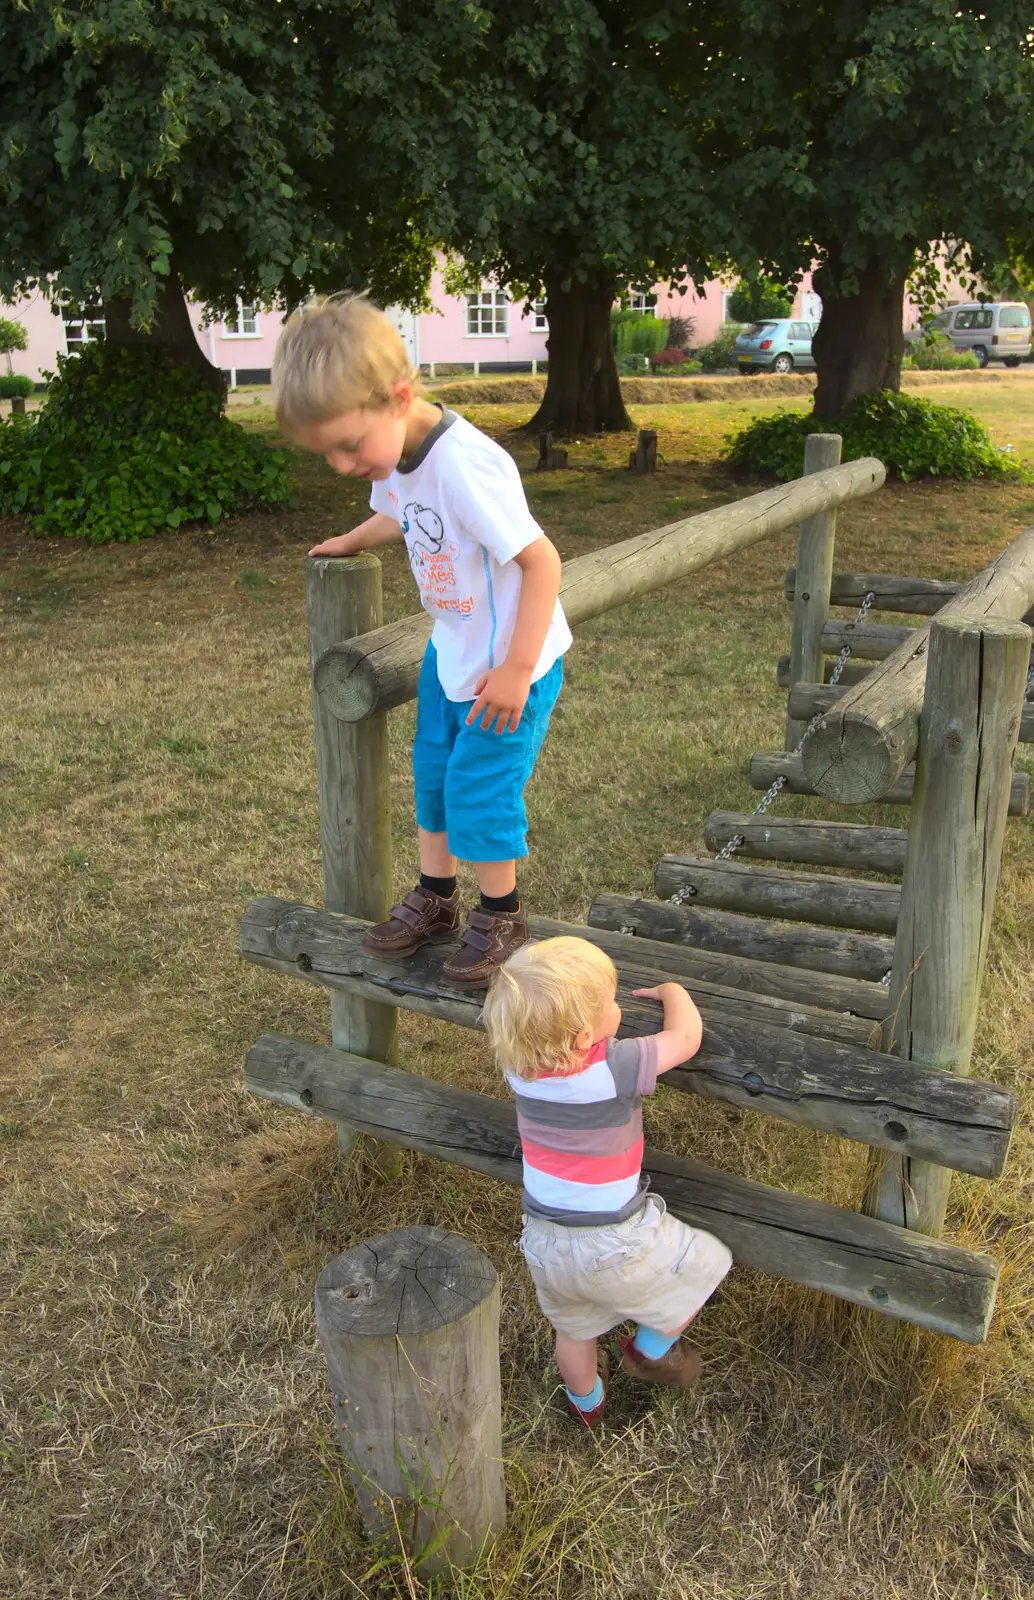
0,344,291,544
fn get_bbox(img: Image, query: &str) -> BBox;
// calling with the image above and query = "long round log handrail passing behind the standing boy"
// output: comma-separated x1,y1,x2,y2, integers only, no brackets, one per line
320,458,887,722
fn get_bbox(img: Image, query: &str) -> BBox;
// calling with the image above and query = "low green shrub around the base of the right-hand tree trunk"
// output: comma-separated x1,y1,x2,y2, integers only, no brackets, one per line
727,389,1029,483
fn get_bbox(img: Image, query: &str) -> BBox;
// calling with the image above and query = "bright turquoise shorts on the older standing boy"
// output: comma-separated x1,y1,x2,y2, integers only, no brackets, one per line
413,643,563,861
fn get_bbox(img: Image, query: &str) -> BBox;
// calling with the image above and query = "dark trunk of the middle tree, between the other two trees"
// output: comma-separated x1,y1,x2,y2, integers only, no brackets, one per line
527,275,632,435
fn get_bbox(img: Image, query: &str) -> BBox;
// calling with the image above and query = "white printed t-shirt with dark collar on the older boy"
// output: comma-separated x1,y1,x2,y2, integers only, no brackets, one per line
370,410,571,701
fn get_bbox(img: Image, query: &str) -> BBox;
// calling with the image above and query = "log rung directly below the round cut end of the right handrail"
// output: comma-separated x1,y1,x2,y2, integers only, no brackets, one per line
704,811,908,875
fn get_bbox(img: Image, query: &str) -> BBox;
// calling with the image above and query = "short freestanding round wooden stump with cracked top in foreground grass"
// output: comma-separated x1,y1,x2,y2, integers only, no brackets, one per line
315,1227,506,1578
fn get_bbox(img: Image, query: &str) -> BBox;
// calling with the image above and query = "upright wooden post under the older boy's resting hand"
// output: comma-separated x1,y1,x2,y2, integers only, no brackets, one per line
306,552,400,1176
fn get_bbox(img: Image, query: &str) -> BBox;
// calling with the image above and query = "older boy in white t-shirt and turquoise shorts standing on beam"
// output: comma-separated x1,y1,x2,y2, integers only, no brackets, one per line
272,296,571,989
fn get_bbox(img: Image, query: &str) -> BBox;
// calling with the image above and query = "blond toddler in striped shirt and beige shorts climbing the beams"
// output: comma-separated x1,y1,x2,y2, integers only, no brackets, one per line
485,938,731,1427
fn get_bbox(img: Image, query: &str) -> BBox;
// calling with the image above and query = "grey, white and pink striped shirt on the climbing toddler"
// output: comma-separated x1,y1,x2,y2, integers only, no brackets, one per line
506,1038,656,1227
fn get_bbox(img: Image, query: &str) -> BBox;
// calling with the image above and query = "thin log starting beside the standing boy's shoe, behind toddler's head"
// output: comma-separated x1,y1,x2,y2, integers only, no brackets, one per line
531,917,887,1021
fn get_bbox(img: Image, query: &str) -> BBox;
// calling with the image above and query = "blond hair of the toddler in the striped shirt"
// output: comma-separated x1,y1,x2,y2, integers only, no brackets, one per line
483,938,618,1080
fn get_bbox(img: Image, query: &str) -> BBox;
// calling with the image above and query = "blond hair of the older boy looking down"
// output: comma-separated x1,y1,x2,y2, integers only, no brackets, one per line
272,294,419,434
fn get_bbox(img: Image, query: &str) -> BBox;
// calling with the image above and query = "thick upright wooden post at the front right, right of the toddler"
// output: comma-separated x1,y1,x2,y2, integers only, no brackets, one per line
863,618,1031,1237
